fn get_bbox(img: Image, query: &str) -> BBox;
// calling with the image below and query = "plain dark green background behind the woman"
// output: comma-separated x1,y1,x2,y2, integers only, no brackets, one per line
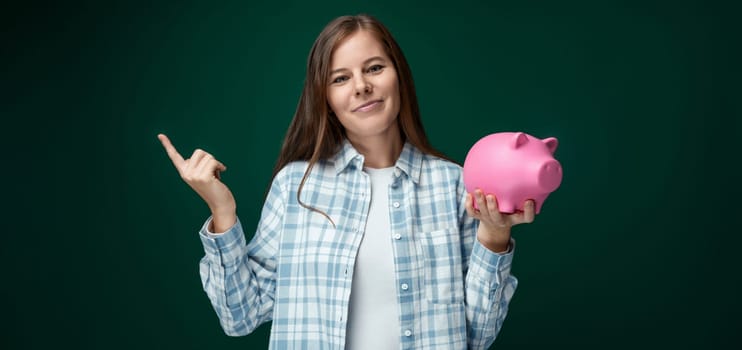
0,0,742,349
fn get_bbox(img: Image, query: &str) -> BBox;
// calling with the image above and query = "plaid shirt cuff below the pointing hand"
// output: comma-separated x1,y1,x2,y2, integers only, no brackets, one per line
199,216,246,267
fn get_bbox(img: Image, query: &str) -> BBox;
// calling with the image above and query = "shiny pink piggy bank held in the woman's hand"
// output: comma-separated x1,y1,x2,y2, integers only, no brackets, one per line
464,132,562,214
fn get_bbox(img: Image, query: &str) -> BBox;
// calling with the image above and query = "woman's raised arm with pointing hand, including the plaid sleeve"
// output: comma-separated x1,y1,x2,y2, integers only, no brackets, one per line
158,134,285,336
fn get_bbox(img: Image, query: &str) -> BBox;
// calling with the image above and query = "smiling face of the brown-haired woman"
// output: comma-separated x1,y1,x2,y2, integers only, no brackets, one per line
327,30,399,141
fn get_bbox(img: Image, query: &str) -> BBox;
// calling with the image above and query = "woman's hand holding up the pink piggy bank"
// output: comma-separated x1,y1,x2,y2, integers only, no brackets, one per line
466,189,536,253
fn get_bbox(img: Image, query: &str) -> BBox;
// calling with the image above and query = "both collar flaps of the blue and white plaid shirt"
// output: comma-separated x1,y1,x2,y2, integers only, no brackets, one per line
332,139,423,183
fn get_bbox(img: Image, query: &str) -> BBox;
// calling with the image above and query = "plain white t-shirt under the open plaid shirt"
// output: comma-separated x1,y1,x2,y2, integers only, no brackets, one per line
345,167,400,350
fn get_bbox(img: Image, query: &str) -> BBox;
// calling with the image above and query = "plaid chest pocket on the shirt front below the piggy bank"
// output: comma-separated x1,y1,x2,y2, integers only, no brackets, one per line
421,229,464,304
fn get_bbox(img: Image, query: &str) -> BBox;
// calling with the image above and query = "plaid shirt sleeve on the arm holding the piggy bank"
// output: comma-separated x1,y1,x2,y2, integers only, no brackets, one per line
458,174,518,349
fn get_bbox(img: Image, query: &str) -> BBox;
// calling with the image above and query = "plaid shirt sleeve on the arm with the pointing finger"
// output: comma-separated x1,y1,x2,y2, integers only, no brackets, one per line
199,173,285,336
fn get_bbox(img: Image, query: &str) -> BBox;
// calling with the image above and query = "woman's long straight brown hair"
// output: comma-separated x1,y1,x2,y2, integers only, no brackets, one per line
272,14,450,225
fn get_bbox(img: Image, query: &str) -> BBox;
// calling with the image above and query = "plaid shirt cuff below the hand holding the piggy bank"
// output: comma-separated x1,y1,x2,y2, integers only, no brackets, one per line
468,238,515,287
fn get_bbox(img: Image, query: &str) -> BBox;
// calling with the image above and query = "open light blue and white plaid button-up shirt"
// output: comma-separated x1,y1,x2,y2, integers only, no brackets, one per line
200,141,517,350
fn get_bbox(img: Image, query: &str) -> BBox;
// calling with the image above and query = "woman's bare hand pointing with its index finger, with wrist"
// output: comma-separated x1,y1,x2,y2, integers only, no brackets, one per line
157,134,237,232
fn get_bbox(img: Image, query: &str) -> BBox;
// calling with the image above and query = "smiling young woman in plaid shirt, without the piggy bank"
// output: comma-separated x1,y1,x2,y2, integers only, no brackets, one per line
158,15,534,350
